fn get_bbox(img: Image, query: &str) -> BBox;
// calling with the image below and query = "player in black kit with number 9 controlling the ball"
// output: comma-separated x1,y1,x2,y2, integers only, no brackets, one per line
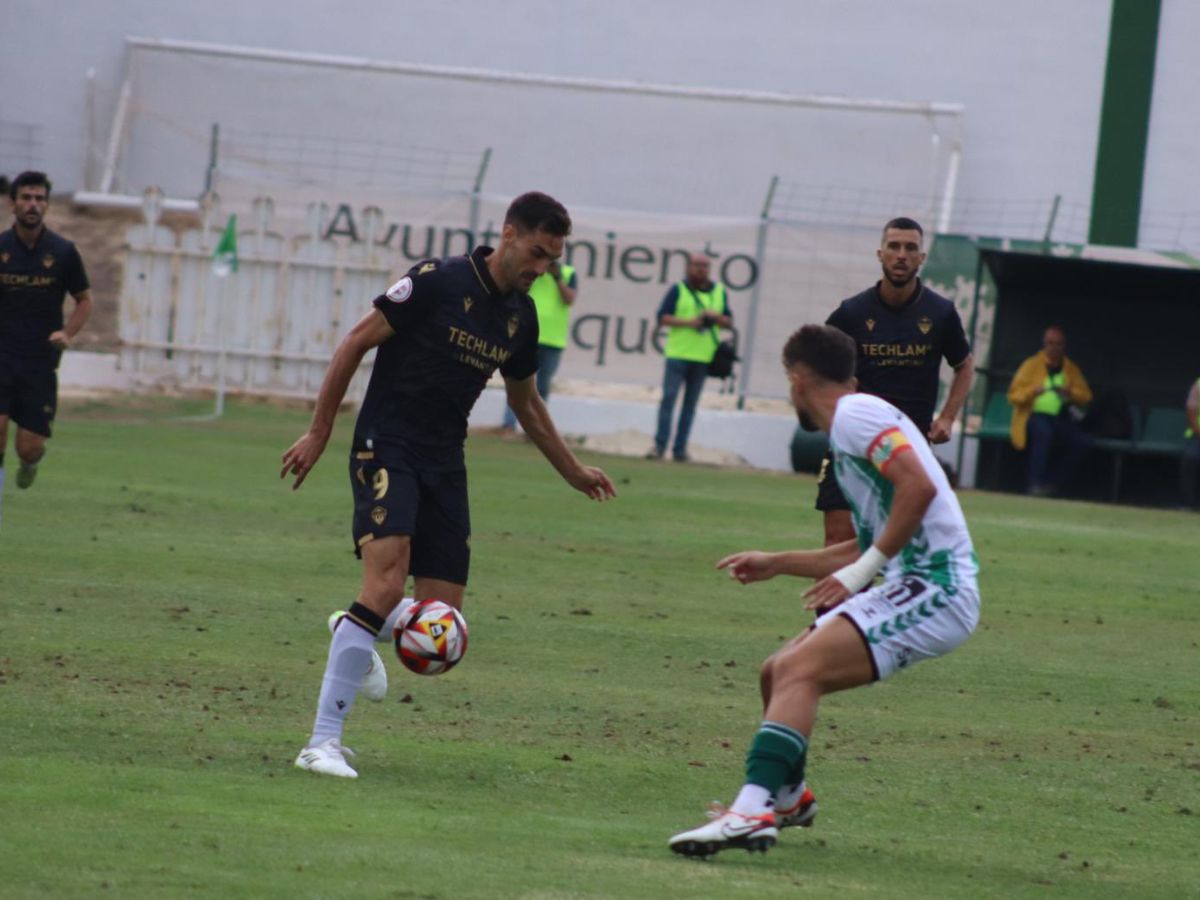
280,192,616,778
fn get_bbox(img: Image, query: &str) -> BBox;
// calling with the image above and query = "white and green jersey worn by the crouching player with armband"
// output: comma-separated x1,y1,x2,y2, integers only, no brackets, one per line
829,394,979,592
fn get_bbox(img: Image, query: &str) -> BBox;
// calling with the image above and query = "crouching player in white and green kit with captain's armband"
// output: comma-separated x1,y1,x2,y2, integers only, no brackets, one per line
670,325,979,857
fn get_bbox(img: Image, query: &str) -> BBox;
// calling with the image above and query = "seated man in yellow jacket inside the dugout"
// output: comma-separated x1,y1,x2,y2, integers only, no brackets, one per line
1008,325,1092,497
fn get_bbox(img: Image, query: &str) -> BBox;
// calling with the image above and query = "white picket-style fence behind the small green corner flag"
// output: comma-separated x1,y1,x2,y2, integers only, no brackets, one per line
118,190,390,401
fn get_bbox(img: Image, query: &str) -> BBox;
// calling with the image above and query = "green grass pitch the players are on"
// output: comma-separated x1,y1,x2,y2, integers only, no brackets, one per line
0,401,1200,899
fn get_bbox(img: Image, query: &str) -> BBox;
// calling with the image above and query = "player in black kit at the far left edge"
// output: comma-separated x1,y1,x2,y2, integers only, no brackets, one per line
0,172,91,525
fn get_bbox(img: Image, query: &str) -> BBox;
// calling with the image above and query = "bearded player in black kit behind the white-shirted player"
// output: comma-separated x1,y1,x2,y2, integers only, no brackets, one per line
805,217,974,547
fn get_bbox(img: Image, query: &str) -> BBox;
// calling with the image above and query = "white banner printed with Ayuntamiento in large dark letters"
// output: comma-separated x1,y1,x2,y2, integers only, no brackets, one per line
206,176,882,397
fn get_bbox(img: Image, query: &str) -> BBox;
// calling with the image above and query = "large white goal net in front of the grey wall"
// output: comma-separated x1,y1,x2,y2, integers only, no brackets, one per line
106,38,961,396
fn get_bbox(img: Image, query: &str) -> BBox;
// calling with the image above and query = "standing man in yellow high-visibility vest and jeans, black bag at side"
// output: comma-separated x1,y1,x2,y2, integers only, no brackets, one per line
647,253,733,462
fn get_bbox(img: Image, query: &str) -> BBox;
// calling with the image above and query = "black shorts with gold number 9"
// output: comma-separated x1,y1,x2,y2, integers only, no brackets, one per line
350,450,470,584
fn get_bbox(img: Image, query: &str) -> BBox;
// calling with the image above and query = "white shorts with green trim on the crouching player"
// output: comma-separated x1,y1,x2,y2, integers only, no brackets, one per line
816,575,979,680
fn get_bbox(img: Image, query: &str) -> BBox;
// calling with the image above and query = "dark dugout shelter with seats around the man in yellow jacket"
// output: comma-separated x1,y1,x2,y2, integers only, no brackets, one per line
966,245,1200,505
